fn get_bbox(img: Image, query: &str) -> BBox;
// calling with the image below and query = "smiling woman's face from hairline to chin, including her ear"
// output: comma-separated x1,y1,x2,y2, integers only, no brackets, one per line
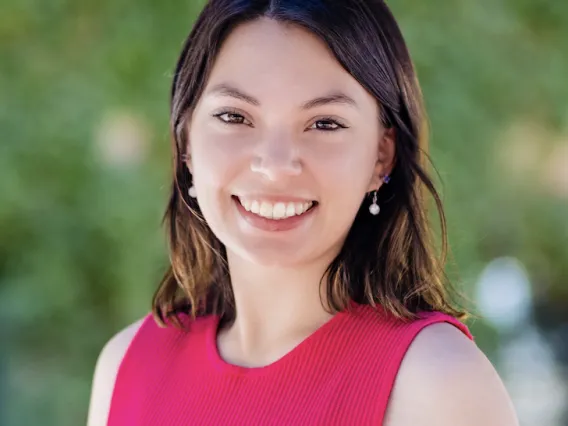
188,19,394,267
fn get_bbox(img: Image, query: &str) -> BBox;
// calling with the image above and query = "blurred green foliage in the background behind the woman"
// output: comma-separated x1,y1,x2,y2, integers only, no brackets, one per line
0,0,568,426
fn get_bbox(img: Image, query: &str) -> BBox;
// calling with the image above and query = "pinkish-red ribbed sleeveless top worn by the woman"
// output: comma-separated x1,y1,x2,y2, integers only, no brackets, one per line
108,305,472,426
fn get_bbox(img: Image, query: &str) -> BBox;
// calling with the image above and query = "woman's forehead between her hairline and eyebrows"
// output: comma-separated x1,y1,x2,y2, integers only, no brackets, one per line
206,18,375,110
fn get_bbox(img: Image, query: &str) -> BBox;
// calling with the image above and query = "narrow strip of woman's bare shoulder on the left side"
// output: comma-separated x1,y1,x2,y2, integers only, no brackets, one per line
87,318,145,426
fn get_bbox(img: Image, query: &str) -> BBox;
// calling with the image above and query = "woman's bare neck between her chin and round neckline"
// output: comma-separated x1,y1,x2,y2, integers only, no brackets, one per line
218,253,332,365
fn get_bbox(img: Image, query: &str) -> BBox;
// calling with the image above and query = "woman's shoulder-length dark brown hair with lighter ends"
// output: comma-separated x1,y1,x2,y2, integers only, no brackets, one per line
152,0,467,327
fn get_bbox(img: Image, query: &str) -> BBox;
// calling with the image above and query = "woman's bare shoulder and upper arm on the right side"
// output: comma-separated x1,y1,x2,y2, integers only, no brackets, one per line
384,323,519,426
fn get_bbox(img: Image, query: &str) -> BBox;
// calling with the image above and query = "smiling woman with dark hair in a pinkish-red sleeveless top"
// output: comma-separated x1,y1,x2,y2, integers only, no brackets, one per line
90,0,517,426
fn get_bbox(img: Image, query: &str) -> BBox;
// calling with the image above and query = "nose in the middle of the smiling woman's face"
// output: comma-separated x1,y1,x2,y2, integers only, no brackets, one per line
250,133,302,181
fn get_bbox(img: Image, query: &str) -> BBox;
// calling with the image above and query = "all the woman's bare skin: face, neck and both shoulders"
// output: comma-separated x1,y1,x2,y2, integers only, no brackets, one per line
89,19,518,426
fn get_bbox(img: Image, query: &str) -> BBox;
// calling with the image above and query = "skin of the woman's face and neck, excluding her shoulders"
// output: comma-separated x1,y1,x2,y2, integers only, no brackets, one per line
188,19,394,365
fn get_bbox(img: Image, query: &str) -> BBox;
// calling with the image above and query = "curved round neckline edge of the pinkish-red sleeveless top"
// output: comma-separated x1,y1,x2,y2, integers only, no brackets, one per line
206,304,353,376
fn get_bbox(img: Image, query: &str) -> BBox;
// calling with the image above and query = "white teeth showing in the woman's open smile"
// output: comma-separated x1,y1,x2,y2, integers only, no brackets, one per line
233,195,318,221
